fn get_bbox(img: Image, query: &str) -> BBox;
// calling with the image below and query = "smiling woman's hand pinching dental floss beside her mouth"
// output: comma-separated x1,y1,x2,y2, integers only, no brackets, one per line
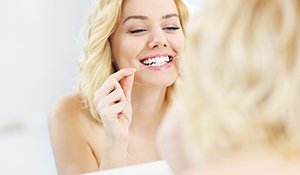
94,68,135,143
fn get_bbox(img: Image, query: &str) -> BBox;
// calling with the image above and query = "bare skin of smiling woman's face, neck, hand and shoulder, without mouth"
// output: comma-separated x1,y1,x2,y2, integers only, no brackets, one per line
49,0,184,174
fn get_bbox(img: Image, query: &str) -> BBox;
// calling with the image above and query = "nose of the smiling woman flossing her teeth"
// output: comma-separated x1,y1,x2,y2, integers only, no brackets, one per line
148,28,168,49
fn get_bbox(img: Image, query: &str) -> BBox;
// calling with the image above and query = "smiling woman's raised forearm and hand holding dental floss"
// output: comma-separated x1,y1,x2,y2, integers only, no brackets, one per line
94,68,135,169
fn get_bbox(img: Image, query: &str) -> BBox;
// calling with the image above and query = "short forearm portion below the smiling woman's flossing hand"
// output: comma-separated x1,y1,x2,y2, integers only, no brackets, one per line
100,143,129,170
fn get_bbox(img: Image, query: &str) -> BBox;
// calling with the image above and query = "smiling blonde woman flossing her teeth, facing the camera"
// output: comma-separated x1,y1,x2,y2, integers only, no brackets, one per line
49,0,188,174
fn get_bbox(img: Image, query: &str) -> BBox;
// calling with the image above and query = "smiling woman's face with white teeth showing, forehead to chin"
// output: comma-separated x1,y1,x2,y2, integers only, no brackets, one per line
110,0,184,86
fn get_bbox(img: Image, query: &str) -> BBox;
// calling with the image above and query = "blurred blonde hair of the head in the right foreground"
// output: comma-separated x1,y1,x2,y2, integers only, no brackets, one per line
178,0,300,162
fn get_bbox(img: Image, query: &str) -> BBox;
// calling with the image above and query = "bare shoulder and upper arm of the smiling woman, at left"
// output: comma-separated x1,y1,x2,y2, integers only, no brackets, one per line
48,93,104,174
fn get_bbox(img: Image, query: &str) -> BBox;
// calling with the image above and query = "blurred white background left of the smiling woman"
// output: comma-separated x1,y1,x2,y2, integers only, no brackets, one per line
0,0,200,175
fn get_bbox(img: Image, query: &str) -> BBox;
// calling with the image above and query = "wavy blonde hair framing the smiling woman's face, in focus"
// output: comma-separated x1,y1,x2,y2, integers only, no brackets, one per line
79,0,189,122
